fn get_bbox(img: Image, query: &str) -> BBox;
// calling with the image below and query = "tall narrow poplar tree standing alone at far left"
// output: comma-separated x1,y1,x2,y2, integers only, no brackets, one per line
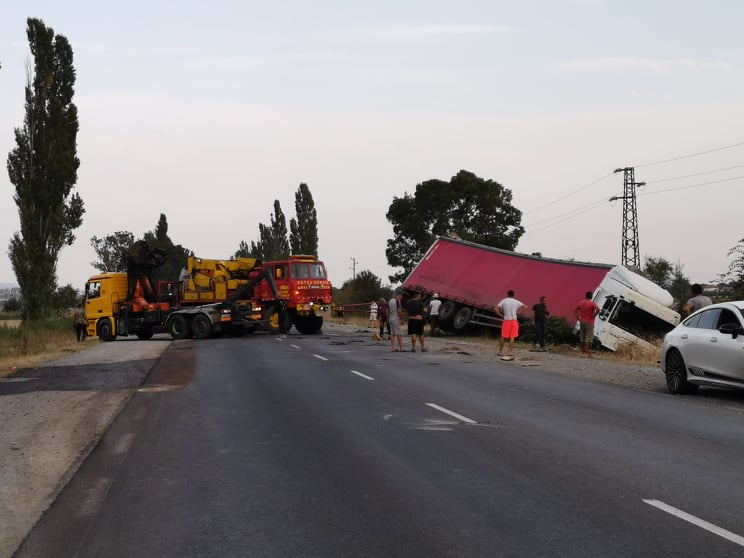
7,18,85,322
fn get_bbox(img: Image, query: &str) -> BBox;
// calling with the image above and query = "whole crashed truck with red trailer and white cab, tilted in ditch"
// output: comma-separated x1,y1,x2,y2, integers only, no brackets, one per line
402,237,679,350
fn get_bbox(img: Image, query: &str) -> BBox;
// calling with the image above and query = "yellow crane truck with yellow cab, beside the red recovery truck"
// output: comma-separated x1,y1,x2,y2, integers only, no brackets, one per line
85,258,288,341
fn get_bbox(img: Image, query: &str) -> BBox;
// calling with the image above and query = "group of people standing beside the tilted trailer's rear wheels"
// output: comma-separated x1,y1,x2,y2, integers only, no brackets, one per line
369,291,442,353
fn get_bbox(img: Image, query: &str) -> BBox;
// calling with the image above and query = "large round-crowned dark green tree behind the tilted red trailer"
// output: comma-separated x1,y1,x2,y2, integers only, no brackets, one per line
385,170,524,283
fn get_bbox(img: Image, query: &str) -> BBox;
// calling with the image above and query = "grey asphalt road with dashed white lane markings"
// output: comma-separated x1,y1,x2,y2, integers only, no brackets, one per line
16,334,744,558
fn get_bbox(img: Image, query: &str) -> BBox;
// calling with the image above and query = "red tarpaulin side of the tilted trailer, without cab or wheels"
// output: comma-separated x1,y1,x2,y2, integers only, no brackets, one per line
403,238,613,324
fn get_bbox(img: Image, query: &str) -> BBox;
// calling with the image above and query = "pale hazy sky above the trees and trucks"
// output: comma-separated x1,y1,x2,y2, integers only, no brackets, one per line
0,0,744,294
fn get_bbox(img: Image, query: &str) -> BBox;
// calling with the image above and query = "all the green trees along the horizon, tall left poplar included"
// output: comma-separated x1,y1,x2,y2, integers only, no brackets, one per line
7,18,744,321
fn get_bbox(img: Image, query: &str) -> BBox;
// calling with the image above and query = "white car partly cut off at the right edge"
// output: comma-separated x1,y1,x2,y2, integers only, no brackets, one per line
659,300,744,393
